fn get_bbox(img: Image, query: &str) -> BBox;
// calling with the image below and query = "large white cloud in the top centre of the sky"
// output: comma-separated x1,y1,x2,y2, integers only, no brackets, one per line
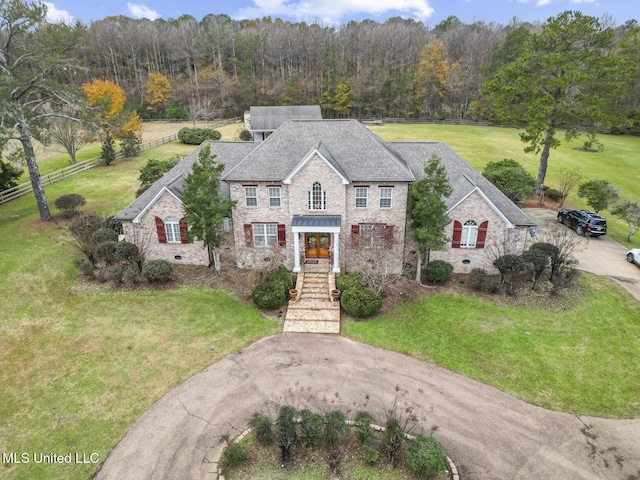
236,0,435,24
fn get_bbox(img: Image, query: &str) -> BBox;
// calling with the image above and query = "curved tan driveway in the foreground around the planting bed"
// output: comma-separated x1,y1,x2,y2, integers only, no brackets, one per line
97,334,640,480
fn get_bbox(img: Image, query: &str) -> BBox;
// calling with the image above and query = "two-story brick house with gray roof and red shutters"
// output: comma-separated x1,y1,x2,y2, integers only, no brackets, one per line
118,120,534,273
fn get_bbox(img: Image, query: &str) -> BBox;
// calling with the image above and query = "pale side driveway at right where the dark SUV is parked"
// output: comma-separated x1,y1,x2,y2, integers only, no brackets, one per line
524,208,640,300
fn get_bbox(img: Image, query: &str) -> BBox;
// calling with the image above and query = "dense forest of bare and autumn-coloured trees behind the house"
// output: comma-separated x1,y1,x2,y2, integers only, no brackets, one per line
73,14,640,120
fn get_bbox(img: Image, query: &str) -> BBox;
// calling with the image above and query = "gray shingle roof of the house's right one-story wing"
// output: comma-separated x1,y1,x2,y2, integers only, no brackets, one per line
389,142,536,226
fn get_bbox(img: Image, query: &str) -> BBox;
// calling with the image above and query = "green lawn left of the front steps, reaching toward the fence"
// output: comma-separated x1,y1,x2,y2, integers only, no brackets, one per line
0,151,280,479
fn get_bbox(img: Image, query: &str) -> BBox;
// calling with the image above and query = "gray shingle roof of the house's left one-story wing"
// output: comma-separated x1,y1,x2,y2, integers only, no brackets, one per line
116,142,256,220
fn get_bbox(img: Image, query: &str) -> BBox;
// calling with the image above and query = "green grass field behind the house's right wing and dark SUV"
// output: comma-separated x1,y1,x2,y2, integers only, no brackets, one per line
371,124,640,248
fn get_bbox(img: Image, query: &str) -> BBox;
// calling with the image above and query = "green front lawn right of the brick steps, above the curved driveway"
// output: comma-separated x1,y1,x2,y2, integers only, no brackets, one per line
342,274,640,417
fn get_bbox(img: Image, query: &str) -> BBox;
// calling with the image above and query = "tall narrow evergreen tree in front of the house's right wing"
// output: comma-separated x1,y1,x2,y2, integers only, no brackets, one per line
408,154,453,282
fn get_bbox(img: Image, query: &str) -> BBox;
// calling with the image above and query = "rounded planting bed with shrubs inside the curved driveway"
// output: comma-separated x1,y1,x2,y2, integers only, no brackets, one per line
219,407,459,480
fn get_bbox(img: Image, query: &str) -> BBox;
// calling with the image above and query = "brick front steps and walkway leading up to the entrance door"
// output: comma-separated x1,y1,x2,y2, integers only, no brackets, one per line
282,271,340,334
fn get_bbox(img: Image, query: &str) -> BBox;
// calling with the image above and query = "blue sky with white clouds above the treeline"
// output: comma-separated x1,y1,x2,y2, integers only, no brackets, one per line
44,0,640,27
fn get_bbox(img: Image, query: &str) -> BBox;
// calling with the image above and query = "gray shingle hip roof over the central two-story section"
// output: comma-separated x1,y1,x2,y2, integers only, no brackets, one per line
223,120,414,182
